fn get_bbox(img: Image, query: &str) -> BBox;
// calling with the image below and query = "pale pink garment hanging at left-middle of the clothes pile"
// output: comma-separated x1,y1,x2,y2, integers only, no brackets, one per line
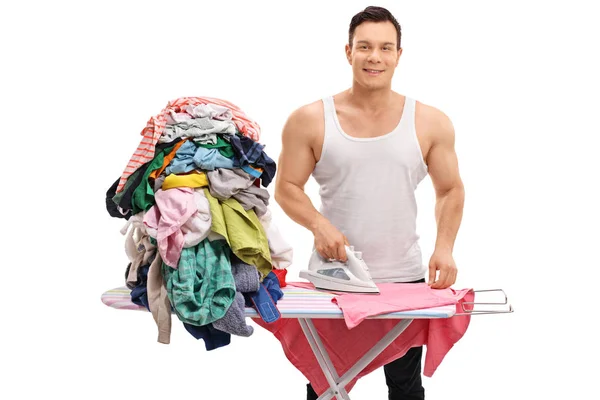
144,187,198,268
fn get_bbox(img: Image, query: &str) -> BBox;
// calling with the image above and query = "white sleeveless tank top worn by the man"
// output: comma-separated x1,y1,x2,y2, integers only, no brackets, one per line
312,97,428,282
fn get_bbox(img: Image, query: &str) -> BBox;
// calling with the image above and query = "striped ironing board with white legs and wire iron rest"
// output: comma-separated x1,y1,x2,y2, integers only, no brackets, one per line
101,283,513,400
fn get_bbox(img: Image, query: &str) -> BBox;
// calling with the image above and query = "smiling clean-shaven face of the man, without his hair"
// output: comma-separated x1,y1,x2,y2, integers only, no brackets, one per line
346,21,402,89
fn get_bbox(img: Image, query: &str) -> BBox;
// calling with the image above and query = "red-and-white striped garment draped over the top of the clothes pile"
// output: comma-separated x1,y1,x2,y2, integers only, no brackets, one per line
116,97,260,193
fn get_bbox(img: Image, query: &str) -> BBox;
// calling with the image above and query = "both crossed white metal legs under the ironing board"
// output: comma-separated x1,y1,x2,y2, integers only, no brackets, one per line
298,318,412,400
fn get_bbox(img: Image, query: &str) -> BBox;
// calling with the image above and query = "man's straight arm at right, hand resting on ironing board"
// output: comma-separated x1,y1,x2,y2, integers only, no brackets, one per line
427,109,465,289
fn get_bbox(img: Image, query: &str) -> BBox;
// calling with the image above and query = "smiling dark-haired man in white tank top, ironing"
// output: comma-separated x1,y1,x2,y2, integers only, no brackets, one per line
275,7,464,399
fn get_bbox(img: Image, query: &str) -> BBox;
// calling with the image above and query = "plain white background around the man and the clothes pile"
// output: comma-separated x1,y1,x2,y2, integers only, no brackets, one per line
0,0,600,400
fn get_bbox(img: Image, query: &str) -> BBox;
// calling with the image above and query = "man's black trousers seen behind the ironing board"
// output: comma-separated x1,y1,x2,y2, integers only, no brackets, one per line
306,279,425,400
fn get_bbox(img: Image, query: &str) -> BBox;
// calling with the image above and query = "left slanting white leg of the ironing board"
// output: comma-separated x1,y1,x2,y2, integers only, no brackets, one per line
298,318,350,400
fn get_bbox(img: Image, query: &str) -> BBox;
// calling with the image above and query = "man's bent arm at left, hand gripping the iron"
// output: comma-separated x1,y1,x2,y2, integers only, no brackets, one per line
274,103,348,261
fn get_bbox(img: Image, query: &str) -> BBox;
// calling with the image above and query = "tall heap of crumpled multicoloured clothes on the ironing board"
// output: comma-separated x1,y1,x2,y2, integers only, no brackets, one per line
106,97,293,350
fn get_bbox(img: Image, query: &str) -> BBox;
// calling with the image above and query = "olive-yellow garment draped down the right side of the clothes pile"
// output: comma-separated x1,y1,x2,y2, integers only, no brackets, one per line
204,189,273,282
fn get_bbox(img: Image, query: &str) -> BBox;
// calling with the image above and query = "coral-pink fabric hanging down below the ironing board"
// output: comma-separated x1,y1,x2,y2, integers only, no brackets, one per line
254,282,475,395
